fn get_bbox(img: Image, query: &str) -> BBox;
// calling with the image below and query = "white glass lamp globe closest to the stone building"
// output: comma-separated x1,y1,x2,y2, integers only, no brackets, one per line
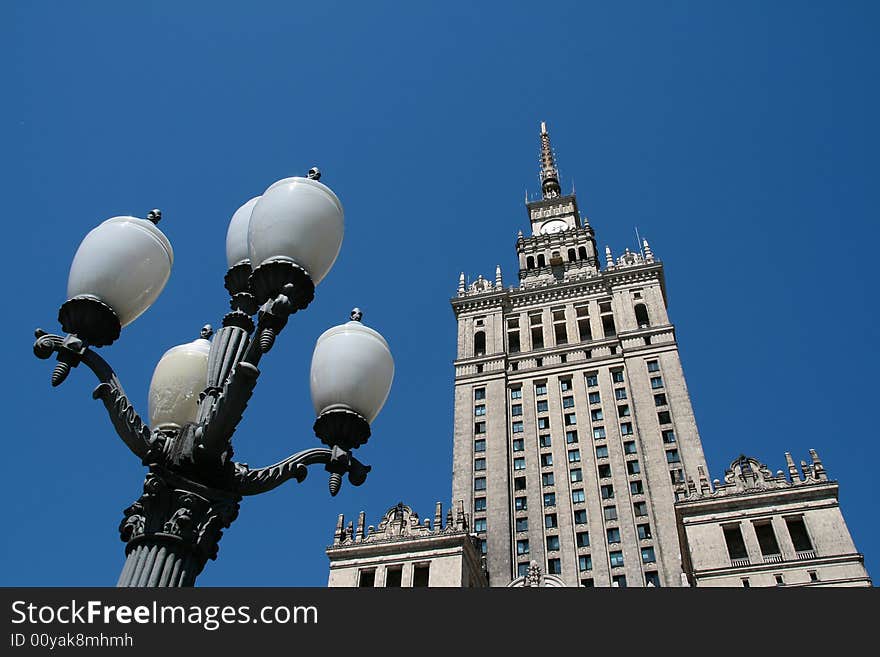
310,314,394,422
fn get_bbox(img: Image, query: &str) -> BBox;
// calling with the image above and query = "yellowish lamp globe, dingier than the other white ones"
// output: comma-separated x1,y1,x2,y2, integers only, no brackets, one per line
149,338,211,429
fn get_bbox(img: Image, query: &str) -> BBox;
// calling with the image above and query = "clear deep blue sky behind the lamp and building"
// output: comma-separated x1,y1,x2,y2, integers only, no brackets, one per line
0,1,880,586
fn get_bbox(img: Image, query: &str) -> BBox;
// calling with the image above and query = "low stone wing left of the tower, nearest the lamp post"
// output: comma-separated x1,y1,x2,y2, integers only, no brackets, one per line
327,502,486,587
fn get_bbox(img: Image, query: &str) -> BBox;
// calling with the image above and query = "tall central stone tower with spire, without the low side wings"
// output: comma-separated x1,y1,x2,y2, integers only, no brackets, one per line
451,123,707,586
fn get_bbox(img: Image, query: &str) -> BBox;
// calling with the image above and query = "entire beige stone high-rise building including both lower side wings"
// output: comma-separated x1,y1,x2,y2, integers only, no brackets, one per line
327,124,871,587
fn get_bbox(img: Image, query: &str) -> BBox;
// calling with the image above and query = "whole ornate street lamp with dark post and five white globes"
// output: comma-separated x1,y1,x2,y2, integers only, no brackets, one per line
34,168,394,587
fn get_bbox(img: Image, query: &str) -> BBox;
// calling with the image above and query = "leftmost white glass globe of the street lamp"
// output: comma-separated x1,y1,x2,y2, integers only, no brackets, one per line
67,217,174,326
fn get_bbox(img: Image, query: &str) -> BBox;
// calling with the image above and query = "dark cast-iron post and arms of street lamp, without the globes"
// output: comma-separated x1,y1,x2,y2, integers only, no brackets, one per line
34,172,382,587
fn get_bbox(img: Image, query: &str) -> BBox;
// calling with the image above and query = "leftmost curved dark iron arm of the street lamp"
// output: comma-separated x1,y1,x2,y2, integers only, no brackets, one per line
34,329,151,459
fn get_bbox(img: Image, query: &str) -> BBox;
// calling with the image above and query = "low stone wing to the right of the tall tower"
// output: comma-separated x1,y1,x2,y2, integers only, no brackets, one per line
675,450,871,587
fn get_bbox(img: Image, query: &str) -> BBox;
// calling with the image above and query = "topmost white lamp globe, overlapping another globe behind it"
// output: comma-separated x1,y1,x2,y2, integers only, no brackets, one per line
248,178,345,285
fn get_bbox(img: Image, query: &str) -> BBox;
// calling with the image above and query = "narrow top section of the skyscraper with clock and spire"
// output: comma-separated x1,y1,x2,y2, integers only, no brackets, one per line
516,123,598,287
